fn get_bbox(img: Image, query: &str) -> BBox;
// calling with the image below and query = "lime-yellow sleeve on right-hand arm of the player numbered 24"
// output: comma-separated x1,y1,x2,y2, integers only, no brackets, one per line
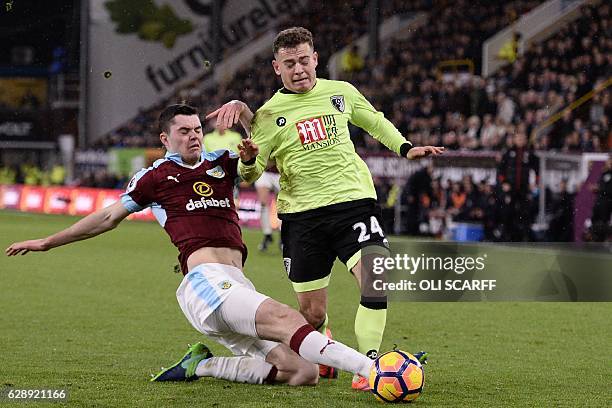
349,84,412,154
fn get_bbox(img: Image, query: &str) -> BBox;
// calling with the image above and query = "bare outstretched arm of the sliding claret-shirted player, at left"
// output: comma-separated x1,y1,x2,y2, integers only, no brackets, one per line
5,201,130,256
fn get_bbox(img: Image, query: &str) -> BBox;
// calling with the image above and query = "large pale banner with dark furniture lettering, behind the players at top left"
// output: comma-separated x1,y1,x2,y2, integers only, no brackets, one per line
87,0,307,140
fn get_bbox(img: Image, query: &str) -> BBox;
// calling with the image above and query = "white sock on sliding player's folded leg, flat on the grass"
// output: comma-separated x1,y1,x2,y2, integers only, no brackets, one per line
195,356,273,384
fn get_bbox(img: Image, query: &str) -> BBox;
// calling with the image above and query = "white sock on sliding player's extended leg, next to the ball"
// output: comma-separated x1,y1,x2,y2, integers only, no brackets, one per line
299,331,372,378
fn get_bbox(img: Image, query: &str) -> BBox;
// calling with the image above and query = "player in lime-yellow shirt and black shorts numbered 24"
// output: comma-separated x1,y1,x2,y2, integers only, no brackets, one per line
209,27,444,391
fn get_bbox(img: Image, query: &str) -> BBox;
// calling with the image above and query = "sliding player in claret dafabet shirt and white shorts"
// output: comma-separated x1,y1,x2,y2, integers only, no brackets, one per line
6,105,382,385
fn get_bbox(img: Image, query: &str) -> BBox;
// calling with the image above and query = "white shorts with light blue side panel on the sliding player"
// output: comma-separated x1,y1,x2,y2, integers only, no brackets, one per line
176,263,279,359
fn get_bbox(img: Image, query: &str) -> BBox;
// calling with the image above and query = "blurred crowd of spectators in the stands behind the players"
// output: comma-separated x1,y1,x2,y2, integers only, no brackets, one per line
0,0,612,241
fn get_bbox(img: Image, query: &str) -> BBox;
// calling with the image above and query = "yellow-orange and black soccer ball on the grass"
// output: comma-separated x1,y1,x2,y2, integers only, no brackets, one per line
370,350,425,402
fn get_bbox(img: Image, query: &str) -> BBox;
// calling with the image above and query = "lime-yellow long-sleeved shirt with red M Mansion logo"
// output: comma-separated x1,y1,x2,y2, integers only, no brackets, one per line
238,78,407,214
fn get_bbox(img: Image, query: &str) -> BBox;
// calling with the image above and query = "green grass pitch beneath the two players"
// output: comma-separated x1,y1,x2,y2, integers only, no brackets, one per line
0,211,612,408
